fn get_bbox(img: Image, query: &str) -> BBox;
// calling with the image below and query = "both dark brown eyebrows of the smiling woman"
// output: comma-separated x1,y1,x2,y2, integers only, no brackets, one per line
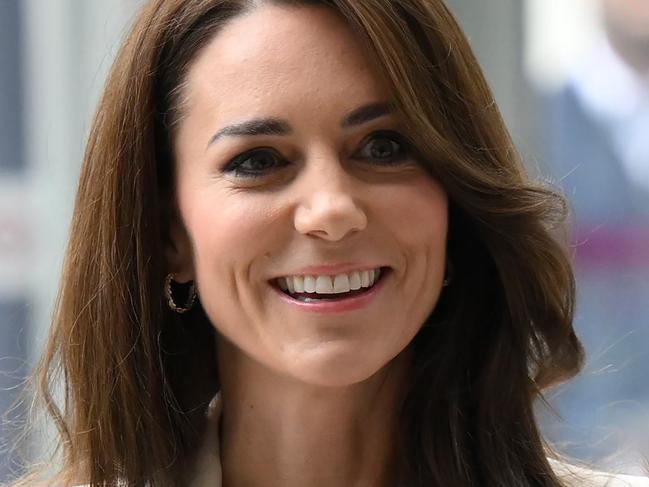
207,102,395,147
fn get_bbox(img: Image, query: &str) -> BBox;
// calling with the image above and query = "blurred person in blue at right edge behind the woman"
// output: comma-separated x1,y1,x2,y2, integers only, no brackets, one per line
543,0,649,468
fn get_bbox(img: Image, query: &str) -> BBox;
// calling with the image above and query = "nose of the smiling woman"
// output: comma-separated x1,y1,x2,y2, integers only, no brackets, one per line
294,159,367,242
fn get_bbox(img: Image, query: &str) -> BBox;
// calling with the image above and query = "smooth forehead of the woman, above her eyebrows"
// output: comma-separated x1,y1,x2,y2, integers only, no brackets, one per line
182,5,387,123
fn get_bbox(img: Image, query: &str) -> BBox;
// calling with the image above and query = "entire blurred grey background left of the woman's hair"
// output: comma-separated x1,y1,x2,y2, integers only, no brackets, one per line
0,0,141,483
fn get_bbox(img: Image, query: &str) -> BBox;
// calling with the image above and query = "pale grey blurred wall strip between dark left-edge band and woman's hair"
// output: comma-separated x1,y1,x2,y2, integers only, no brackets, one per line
21,0,146,357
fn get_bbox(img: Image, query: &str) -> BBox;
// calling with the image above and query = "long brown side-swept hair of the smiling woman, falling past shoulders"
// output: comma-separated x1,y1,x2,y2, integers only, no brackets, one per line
19,0,583,487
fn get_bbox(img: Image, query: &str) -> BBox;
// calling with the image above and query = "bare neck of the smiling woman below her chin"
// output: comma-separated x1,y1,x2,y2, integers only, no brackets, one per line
219,343,409,487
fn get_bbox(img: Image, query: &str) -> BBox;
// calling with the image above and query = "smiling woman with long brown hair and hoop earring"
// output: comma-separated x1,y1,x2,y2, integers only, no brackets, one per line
10,0,648,487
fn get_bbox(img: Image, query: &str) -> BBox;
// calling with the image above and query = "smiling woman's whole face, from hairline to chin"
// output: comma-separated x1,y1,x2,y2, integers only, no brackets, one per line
171,2,447,385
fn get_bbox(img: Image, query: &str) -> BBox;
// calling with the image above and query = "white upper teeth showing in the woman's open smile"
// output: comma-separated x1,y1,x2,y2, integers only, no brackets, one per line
277,269,381,294
